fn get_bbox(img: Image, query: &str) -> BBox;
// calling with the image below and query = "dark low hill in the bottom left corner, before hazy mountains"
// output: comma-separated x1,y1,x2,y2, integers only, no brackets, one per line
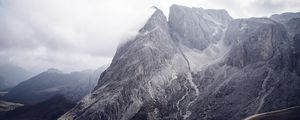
0,95,75,120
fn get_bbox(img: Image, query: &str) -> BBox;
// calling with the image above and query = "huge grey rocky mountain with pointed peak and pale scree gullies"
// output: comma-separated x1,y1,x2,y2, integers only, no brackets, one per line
59,5,300,120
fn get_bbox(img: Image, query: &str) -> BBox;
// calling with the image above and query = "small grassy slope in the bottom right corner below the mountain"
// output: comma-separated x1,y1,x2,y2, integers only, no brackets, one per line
245,106,300,120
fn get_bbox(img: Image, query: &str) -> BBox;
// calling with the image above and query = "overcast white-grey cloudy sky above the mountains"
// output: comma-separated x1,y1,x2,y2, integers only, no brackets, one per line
0,0,300,72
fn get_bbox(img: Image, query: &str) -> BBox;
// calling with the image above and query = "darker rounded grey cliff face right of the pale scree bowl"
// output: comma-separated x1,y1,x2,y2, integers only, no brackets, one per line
225,18,291,67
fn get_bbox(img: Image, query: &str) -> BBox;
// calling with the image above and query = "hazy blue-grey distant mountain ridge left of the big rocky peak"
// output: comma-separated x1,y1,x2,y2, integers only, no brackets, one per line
3,67,105,104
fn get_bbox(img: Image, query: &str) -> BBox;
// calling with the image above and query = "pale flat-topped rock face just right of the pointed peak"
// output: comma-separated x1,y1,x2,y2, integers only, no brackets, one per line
169,5,232,50
